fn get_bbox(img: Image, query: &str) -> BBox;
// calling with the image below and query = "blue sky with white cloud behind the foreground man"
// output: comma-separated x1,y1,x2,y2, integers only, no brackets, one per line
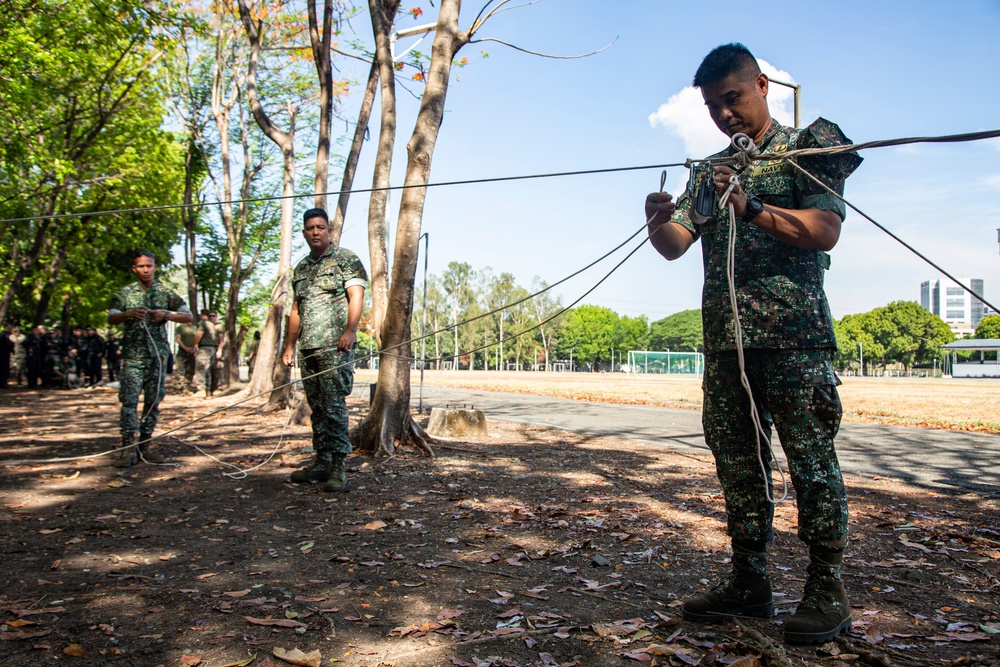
324,0,1000,321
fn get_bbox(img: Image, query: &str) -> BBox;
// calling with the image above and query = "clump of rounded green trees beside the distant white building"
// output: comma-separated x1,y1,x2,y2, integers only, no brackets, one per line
834,301,955,368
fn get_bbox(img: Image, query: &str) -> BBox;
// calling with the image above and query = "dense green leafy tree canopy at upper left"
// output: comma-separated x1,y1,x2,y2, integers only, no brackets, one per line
0,0,189,324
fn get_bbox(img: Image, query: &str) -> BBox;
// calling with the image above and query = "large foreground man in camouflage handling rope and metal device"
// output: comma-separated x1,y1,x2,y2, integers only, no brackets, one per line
646,44,861,643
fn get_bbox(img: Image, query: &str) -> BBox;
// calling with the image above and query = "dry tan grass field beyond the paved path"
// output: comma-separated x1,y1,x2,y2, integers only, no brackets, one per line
358,370,1000,433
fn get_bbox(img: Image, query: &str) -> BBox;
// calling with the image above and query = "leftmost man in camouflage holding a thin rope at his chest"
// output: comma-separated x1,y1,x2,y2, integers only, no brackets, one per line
108,250,193,468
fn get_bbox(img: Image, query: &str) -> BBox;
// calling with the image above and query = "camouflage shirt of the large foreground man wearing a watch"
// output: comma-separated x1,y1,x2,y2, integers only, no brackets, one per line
671,118,861,352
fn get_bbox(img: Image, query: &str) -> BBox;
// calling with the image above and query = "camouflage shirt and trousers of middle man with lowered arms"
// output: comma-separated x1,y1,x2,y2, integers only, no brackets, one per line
292,245,368,454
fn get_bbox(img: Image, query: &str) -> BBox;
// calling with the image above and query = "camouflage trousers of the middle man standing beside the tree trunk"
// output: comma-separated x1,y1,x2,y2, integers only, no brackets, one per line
299,348,354,454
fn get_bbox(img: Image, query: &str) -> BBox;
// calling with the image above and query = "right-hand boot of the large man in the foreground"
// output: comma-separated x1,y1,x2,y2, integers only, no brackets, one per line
785,547,851,644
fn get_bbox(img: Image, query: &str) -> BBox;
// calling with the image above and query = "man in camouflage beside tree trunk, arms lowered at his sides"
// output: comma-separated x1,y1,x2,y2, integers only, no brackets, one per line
281,208,368,491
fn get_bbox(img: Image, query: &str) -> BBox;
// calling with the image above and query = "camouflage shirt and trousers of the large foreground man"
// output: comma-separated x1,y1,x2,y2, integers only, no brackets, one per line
672,119,861,549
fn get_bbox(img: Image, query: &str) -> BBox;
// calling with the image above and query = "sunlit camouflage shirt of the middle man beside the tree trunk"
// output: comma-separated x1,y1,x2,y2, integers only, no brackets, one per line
292,245,368,350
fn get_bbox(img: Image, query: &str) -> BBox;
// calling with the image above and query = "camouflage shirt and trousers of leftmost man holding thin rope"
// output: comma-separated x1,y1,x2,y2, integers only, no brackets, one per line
108,282,191,439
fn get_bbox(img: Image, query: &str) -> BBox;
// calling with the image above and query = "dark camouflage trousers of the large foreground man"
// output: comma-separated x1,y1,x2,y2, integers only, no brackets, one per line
702,349,847,549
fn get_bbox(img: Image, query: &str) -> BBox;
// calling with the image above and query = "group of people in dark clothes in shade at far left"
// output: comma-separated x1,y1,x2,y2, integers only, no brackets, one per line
0,324,121,389
